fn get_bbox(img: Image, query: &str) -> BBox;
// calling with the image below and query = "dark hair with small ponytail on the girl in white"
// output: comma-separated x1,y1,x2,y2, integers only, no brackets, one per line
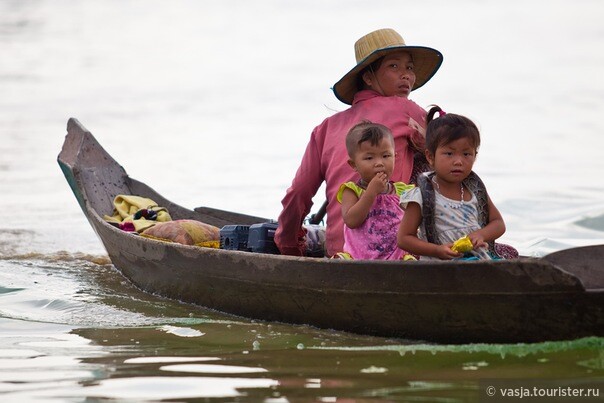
426,105,480,155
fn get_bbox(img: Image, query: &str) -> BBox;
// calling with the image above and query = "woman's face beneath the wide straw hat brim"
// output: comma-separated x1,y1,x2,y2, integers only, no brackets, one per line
364,51,415,98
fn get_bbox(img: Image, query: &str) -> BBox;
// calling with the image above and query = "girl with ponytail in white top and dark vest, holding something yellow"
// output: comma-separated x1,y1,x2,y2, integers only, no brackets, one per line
397,106,505,259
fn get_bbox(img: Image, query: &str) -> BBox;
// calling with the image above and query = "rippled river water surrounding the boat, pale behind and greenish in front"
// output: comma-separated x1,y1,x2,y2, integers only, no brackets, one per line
0,0,604,402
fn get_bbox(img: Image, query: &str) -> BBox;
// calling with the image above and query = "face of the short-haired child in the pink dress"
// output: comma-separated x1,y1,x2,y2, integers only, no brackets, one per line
348,138,395,182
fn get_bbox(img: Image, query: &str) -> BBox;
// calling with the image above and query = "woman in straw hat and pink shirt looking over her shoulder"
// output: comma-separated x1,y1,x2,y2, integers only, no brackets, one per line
275,29,443,256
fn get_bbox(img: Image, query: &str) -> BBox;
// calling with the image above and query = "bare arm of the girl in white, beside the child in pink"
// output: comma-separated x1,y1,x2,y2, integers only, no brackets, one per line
396,203,461,259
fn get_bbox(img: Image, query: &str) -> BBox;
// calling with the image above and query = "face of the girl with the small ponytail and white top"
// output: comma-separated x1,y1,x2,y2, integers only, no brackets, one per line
426,137,476,183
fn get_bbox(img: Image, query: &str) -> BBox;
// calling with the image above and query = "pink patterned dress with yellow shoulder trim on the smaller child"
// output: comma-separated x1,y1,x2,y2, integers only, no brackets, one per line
337,182,413,260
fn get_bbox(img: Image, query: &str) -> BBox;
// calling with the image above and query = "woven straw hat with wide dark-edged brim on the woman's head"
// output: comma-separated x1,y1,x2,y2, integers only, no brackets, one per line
333,28,443,105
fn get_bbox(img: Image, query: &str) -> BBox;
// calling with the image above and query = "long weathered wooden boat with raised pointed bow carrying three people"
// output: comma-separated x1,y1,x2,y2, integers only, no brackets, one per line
58,119,604,343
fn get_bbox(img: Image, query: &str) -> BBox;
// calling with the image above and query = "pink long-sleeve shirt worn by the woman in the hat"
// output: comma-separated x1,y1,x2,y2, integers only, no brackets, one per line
275,90,426,256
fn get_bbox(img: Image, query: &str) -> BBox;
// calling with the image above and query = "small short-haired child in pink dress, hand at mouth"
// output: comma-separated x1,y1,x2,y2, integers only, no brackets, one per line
336,121,413,260
